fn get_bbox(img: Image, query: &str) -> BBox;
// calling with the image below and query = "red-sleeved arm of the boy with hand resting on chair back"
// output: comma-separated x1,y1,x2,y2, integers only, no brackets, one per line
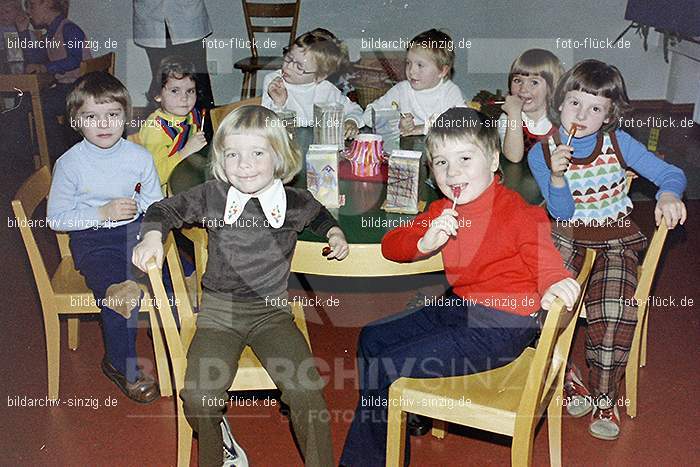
513,206,580,310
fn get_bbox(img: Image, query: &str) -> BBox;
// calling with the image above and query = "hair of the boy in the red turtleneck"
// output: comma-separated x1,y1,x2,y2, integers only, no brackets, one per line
425,107,501,164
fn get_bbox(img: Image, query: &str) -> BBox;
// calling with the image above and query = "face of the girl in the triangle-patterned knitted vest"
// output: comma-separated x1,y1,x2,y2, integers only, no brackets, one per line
559,91,612,138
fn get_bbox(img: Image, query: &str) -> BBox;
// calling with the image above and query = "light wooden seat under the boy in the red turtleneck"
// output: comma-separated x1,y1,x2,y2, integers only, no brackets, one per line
391,347,535,436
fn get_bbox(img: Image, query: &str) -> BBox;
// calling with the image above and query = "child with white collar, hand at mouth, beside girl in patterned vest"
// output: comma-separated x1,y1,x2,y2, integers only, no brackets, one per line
498,49,564,162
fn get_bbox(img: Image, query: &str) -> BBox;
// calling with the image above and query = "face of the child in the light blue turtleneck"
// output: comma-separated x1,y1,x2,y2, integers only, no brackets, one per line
75,97,125,149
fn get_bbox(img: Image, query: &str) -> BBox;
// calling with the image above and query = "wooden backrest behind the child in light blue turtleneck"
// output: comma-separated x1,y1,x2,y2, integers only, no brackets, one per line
12,166,60,313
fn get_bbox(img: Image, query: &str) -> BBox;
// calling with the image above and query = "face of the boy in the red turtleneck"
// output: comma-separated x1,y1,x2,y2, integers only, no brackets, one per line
432,140,498,204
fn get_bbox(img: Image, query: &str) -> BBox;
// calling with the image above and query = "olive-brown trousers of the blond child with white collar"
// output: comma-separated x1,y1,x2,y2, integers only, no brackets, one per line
181,292,333,467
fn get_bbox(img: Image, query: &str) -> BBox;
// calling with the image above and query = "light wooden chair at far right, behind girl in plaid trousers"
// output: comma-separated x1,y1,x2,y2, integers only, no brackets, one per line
579,218,668,418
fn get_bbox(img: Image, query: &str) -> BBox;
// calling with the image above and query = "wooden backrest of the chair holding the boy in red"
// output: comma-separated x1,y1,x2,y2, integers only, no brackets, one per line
515,249,595,439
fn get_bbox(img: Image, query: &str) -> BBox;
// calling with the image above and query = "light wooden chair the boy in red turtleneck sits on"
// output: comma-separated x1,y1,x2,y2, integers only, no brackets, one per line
386,250,595,466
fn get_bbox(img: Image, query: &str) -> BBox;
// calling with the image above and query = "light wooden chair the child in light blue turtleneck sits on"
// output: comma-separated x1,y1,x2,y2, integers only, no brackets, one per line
12,166,172,399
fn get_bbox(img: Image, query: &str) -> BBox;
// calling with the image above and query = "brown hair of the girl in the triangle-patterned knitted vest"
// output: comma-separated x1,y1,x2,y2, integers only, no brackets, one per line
547,59,631,131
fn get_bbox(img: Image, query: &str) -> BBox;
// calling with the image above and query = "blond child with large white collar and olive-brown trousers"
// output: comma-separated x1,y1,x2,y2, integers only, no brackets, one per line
133,106,348,467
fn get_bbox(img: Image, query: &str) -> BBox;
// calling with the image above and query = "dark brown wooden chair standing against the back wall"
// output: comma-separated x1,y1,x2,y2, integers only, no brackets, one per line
233,0,301,99
